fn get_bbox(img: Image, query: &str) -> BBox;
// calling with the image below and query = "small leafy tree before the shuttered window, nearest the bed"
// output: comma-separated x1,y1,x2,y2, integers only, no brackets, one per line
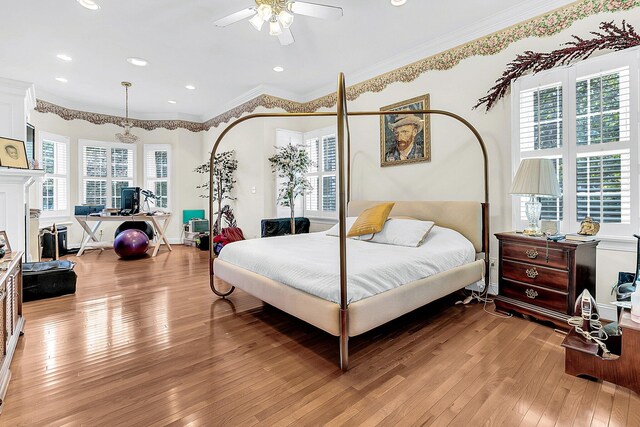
269,143,312,234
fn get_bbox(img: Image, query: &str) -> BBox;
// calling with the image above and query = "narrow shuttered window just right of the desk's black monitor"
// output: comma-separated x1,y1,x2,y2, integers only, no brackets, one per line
144,144,171,209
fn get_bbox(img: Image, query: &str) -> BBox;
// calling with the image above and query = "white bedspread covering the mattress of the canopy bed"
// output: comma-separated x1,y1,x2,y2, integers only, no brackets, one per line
220,226,475,303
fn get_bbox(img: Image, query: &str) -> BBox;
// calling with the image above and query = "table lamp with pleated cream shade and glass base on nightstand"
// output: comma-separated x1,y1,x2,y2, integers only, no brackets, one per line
510,159,560,236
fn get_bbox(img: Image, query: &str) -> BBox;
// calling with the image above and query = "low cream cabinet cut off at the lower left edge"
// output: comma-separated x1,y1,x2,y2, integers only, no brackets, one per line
0,252,24,411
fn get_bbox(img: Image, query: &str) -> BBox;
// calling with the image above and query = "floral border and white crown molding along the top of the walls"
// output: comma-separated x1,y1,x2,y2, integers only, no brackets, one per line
36,0,640,132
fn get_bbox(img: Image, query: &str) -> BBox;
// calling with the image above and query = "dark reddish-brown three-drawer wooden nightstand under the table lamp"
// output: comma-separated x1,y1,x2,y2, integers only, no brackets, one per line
495,232,599,331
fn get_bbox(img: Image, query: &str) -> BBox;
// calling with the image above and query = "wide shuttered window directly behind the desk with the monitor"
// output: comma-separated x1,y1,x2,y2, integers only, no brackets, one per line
79,141,135,209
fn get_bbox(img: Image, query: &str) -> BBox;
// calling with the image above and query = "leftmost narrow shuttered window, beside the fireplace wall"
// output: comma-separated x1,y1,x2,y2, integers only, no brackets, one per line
40,132,69,217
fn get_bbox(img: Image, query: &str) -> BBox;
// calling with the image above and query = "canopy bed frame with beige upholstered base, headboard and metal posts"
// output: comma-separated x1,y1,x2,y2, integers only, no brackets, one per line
209,73,489,371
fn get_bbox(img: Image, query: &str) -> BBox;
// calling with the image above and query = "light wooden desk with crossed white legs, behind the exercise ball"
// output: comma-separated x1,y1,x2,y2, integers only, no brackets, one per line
76,213,171,257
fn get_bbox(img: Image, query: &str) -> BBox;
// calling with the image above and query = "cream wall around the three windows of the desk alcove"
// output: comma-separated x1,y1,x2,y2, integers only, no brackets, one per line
31,112,202,245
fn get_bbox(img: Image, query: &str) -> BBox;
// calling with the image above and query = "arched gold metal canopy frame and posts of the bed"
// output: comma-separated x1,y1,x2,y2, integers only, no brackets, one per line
209,73,490,371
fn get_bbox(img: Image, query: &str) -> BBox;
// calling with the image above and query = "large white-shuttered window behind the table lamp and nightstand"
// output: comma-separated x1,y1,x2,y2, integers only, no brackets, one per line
512,49,640,236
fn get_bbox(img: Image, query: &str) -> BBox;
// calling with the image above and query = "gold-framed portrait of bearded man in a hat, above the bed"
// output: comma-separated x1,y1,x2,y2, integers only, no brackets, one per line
380,93,431,167
